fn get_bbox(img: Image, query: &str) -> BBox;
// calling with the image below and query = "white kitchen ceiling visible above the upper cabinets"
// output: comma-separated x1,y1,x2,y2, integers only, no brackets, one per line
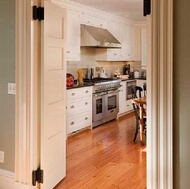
72,0,145,21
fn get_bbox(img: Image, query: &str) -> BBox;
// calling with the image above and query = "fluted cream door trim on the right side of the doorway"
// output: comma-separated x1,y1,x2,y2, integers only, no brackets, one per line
147,0,173,189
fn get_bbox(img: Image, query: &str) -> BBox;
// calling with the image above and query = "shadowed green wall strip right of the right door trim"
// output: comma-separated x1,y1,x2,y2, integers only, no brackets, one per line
173,0,190,189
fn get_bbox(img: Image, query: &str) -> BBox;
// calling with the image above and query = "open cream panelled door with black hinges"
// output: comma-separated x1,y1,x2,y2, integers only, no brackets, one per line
40,1,66,189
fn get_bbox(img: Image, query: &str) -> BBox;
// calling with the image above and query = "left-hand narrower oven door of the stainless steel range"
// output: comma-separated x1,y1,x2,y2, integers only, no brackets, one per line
92,92,106,122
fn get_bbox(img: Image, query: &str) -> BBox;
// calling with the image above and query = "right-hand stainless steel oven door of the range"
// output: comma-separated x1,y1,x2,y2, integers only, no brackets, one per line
105,90,119,116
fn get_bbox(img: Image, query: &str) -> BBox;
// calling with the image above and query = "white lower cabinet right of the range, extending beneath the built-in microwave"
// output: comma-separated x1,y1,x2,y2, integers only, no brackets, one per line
118,81,133,116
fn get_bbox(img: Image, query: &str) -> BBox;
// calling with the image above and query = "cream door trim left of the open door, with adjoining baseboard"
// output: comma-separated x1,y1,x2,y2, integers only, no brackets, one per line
0,0,38,189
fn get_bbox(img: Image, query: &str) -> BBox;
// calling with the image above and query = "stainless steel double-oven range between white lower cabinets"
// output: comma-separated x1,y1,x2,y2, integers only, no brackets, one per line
92,78,121,127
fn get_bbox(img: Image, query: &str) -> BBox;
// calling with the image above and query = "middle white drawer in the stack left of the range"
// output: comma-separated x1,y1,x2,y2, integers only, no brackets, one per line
67,97,92,116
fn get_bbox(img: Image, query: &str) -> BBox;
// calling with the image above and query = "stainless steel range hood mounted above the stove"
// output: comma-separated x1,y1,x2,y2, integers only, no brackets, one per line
81,24,121,48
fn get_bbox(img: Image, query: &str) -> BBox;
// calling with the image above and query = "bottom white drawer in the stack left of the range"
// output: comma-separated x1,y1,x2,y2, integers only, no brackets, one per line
67,112,92,134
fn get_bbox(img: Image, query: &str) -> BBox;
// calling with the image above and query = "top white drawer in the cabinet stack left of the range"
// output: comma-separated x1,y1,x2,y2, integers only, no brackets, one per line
67,87,92,100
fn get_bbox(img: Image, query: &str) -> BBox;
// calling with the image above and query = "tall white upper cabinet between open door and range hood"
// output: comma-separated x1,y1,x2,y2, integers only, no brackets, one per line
66,10,80,61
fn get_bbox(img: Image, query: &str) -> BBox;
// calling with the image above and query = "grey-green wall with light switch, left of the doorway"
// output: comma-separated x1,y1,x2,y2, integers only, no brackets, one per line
0,0,15,171
